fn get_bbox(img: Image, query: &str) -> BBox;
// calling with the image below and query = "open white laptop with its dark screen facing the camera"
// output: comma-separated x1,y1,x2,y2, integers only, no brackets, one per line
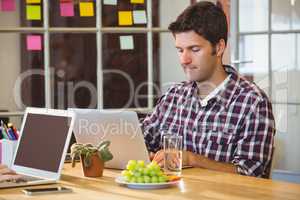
0,108,75,188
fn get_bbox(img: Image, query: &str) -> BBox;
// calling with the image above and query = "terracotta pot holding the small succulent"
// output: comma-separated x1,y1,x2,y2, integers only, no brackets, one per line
81,154,104,177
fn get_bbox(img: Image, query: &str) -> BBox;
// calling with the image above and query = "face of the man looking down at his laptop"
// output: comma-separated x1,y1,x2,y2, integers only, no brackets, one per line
175,31,217,82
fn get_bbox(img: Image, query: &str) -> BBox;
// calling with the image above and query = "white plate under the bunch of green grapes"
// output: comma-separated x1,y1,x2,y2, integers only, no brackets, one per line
115,176,180,190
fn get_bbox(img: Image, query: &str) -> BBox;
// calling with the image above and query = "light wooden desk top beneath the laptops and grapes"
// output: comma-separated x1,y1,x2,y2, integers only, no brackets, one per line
0,164,300,200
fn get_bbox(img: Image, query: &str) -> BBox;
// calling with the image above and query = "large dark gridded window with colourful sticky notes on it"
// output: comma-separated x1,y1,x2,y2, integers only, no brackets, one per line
0,0,195,114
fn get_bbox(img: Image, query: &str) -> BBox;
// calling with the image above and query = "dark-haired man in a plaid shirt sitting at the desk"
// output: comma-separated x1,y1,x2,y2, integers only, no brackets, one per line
142,1,275,176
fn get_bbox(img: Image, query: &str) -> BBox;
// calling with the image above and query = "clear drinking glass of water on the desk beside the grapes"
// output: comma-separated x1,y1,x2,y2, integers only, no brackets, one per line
163,135,182,176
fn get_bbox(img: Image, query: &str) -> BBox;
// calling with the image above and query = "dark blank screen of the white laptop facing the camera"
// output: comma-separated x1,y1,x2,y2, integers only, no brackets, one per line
14,113,71,172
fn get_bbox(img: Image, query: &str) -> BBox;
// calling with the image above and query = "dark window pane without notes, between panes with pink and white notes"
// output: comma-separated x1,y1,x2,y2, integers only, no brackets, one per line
50,33,97,109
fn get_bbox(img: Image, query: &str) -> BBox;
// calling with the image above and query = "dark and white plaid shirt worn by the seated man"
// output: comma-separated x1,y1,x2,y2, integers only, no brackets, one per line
142,66,275,176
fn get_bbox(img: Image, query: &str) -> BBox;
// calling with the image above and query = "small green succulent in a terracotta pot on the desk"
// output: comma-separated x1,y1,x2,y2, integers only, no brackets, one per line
71,141,113,177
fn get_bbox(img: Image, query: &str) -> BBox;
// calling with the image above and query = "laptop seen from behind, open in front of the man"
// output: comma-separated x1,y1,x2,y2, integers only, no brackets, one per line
69,108,150,169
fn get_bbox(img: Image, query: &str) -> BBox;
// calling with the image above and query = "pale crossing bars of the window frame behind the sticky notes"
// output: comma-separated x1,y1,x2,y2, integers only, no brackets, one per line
0,0,176,116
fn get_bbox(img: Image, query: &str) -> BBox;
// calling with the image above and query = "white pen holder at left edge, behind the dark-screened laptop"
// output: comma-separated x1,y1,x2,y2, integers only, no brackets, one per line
0,139,18,167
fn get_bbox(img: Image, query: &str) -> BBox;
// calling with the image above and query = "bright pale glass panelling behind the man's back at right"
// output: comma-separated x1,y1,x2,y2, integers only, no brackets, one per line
231,0,300,172
